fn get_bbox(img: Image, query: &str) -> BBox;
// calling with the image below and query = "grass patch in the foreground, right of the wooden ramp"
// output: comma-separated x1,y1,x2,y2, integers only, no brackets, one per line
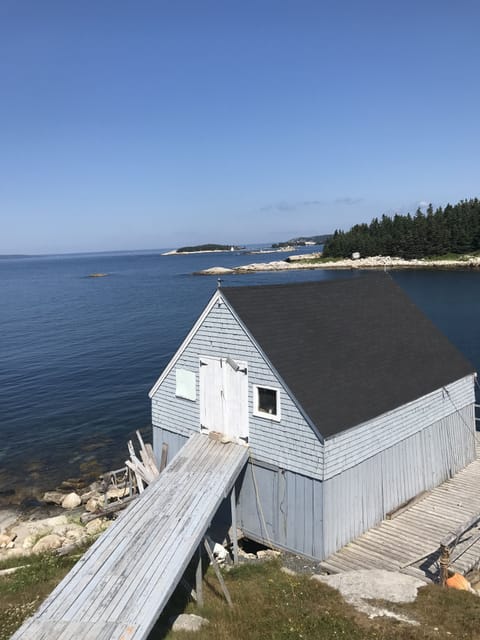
149,562,480,640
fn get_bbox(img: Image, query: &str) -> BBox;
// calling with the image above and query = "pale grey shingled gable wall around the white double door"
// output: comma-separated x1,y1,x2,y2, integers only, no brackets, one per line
152,303,323,479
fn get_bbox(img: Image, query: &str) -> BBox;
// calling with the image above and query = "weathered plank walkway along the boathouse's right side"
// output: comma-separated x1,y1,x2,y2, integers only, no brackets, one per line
320,447,480,581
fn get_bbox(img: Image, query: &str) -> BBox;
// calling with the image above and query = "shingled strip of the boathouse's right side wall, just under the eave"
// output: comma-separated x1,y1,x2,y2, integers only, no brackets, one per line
324,375,475,480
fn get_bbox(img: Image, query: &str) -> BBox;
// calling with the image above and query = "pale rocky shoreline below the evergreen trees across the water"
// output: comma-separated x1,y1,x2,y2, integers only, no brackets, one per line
195,255,480,276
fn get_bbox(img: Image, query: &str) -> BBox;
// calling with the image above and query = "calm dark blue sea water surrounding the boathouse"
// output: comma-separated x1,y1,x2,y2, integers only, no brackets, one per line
0,252,480,497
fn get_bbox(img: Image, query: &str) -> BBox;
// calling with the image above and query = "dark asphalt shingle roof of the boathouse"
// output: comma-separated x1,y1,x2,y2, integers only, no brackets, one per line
222,273,474,438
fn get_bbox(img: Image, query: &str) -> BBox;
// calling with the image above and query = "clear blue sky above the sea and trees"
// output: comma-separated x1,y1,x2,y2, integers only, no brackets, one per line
0,0,480,253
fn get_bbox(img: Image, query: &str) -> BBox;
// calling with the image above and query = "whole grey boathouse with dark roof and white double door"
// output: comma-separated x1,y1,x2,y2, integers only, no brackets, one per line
150,274,475,559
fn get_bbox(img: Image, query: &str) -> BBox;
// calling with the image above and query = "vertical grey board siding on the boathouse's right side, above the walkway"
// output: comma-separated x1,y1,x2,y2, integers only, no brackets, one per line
323,404,475,556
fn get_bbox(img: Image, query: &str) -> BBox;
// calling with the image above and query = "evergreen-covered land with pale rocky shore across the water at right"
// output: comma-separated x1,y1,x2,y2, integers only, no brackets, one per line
195,198,480,275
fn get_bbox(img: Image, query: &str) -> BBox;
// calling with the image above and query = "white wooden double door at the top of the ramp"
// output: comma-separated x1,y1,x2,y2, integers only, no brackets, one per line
200,357,248,438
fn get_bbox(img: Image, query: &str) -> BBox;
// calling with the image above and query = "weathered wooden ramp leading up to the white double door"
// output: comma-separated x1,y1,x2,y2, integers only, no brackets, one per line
12,433,248,640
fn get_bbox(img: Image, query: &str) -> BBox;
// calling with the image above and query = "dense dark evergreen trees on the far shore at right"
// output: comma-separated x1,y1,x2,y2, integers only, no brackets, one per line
323,198,480,260
